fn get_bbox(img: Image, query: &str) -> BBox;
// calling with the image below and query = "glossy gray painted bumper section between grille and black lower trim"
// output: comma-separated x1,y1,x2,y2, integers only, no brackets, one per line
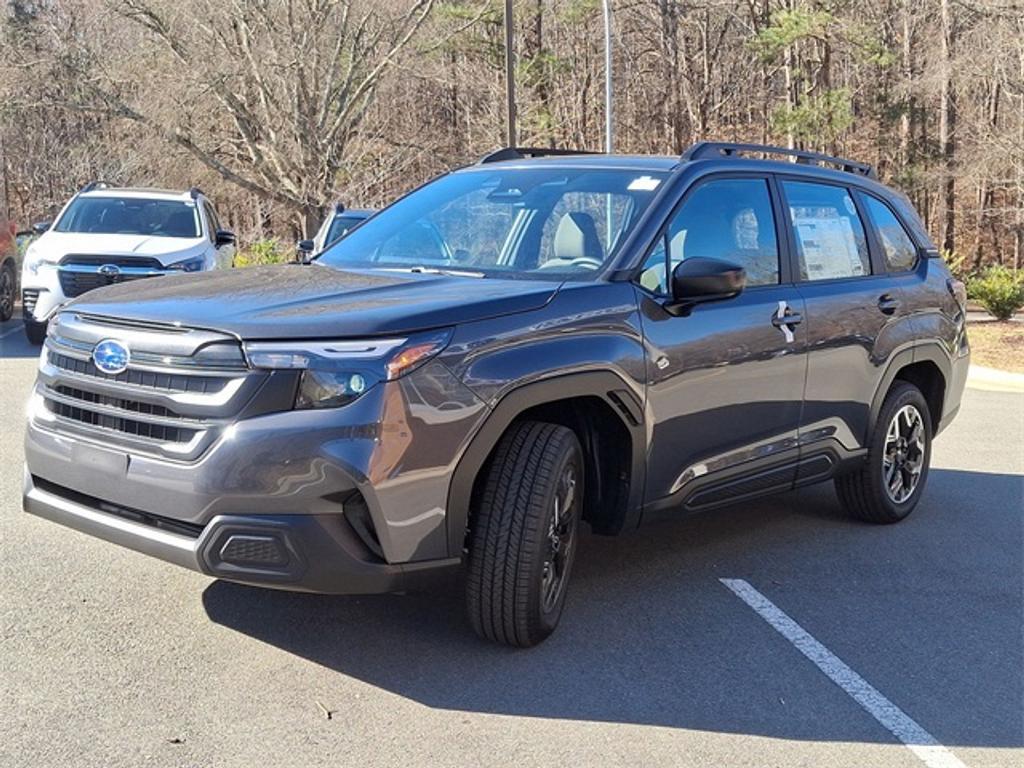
25,362,485,563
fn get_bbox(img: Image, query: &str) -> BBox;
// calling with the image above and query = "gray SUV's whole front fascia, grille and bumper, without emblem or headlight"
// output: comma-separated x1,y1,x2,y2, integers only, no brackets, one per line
25,312,487,593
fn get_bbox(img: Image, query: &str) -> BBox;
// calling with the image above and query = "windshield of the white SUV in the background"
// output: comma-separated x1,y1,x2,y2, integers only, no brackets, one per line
53,198,202,238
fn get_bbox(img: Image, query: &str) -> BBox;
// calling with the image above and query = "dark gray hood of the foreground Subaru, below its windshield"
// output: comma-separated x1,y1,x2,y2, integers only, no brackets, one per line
68,264,559,339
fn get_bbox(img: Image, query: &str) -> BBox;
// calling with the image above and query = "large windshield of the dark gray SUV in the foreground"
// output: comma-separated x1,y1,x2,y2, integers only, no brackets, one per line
318,168,665,280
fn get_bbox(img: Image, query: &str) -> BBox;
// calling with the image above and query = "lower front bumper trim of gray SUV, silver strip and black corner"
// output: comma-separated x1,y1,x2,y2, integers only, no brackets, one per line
23,469,460,594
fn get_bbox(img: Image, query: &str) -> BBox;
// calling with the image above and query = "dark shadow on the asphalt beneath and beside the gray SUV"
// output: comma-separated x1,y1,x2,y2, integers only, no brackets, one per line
203,470,1024,746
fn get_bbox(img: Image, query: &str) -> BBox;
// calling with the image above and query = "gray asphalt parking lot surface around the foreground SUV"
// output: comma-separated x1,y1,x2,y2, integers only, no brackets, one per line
0,322,1024,768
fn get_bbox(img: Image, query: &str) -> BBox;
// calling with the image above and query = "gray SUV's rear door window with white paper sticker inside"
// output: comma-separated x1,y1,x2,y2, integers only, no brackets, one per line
782,181,871,281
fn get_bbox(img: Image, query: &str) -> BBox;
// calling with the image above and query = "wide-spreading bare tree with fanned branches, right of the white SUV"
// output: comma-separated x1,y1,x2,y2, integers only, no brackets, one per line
101,0,434,234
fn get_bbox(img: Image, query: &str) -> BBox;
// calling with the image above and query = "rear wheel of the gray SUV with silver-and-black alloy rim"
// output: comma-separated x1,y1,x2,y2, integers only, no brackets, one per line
836,381,932,523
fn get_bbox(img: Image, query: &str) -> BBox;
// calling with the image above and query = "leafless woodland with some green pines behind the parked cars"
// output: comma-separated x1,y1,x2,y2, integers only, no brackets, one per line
0,0,1024,266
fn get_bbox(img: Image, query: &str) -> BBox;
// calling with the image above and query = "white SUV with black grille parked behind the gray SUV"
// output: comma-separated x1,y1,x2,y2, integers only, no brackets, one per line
22,182,234,344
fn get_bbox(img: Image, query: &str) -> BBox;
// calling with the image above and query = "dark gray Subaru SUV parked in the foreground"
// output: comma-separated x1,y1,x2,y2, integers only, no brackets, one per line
24,143,969,646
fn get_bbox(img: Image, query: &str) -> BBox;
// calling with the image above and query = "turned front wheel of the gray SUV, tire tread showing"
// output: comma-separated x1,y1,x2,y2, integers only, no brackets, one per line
466,421,584,648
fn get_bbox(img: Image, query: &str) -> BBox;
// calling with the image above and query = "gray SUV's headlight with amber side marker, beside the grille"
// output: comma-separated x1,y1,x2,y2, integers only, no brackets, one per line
245,331,452,409
